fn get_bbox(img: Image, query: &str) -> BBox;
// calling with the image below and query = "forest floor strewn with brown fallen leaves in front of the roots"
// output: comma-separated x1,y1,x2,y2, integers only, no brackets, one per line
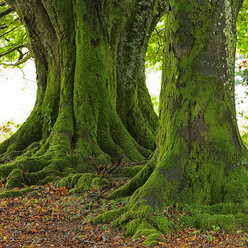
0,164,248,248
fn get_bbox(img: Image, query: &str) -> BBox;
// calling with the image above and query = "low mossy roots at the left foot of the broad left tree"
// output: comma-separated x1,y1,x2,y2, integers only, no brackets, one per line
0,155,89,189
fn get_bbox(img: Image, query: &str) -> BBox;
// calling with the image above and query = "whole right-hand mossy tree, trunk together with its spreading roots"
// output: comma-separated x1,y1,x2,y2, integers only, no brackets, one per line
94,0,248,244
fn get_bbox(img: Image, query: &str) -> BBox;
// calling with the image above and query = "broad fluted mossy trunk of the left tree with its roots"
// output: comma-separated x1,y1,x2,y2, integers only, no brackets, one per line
0,0,162,187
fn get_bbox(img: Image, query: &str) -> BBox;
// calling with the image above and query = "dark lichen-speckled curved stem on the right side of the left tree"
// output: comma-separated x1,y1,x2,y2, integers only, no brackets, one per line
117,1,166,149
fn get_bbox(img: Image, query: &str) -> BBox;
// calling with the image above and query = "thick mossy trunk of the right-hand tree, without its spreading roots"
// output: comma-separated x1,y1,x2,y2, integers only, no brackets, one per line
140,1,247,205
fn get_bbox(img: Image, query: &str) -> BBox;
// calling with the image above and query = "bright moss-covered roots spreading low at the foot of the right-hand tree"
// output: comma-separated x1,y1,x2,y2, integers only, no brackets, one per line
92,201,248,246
